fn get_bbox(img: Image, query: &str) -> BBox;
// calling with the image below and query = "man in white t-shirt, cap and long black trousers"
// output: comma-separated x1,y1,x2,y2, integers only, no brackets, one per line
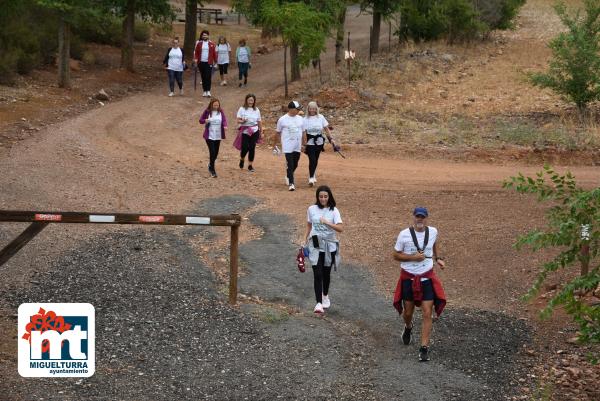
277,100,304,191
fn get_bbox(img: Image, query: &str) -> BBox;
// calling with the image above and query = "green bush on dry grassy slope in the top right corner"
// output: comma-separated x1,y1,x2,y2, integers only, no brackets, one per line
528,0,600,114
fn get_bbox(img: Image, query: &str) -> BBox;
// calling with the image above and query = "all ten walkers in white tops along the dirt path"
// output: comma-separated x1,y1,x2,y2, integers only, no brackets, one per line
171,31,446,362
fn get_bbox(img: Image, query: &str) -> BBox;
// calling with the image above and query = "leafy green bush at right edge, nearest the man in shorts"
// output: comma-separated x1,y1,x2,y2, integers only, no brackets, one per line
504,166,600,343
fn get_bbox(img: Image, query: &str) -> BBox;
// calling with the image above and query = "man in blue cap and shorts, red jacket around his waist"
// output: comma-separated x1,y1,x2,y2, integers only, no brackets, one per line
393,207,446,362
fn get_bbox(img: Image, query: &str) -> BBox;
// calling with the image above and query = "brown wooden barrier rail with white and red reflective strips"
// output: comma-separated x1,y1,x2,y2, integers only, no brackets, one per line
0,210,242,305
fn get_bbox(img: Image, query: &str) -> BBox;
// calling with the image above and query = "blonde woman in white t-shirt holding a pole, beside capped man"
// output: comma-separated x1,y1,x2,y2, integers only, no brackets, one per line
302,102,335,187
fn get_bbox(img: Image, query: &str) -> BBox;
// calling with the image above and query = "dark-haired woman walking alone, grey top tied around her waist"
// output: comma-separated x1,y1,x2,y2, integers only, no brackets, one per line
305,185,342,314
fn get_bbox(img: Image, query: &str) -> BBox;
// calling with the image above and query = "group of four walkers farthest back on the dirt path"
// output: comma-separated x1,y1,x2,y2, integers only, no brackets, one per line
163,30,252,97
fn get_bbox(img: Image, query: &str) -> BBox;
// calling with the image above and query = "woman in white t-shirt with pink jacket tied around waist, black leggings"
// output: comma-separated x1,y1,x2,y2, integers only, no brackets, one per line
237,93,263,173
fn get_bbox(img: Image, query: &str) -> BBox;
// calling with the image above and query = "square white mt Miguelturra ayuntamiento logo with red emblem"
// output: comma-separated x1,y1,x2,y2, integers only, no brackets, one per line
18,303,96,377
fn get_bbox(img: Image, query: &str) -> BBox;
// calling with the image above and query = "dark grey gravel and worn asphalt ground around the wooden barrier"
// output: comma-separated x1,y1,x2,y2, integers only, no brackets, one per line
0,196,527,400
